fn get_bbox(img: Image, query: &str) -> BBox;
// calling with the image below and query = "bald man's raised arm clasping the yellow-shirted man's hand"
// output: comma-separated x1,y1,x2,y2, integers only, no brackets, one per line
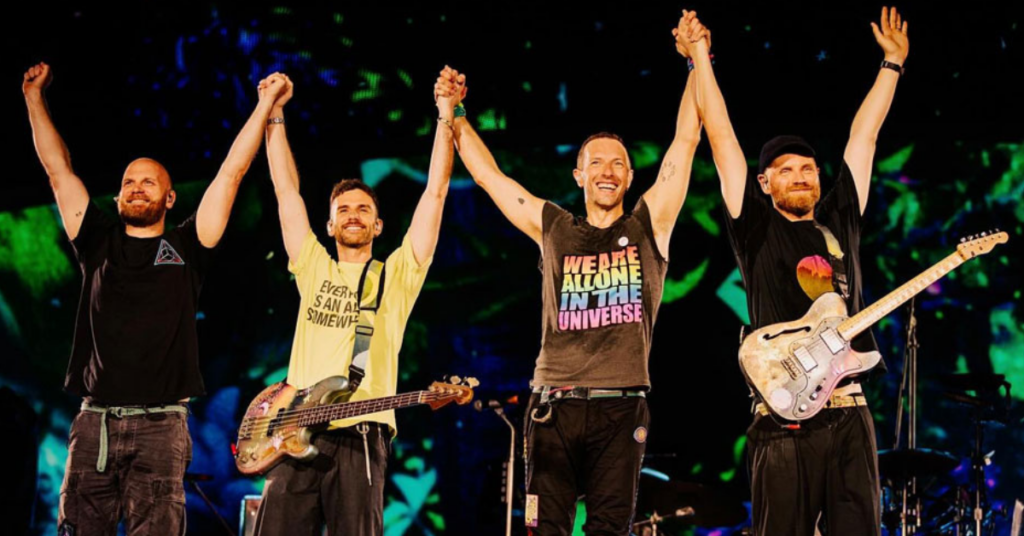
196,73,286,248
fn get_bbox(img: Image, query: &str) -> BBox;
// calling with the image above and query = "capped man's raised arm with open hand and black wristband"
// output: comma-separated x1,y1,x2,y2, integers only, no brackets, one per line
843,7,910,213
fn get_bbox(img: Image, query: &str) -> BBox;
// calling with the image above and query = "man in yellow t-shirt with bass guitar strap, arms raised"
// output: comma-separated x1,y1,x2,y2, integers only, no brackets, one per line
256,72,458,536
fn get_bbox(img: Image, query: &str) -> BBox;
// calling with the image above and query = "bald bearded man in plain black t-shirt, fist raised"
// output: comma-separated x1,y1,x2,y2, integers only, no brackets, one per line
22,64,285,535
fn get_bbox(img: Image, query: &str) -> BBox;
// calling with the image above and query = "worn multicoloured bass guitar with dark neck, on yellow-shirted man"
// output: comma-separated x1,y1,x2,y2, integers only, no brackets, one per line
231,376,479,475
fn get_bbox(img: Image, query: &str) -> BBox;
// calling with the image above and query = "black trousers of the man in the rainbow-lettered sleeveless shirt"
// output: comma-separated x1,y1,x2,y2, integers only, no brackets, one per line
525,395,650,536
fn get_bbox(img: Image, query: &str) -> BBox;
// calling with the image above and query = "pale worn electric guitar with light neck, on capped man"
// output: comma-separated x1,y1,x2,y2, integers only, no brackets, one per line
739,230,1010,421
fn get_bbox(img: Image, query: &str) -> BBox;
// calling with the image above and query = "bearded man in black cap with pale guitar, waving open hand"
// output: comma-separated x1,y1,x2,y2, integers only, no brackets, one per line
694,8,908,536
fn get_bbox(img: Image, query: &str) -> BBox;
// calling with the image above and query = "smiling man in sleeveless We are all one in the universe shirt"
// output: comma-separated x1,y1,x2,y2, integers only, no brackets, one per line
437,11,700,535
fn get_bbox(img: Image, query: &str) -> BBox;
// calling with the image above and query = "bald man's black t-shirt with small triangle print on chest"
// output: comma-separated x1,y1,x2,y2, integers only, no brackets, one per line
65,203,212,404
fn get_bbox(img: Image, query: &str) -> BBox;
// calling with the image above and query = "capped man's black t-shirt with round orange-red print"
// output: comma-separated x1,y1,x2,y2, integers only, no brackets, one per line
725,162,885,370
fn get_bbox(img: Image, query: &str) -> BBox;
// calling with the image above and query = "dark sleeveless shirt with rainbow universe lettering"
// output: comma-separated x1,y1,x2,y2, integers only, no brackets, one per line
532,198,668,387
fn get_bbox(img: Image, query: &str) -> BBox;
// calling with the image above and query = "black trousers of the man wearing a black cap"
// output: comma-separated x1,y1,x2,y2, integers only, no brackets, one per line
746,406,882,536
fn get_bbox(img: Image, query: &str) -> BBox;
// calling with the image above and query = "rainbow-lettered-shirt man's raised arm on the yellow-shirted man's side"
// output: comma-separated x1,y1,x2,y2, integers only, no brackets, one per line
435,67,544,250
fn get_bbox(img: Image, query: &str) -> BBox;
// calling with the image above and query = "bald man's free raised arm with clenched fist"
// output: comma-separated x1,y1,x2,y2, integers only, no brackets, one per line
22,64,89,240
